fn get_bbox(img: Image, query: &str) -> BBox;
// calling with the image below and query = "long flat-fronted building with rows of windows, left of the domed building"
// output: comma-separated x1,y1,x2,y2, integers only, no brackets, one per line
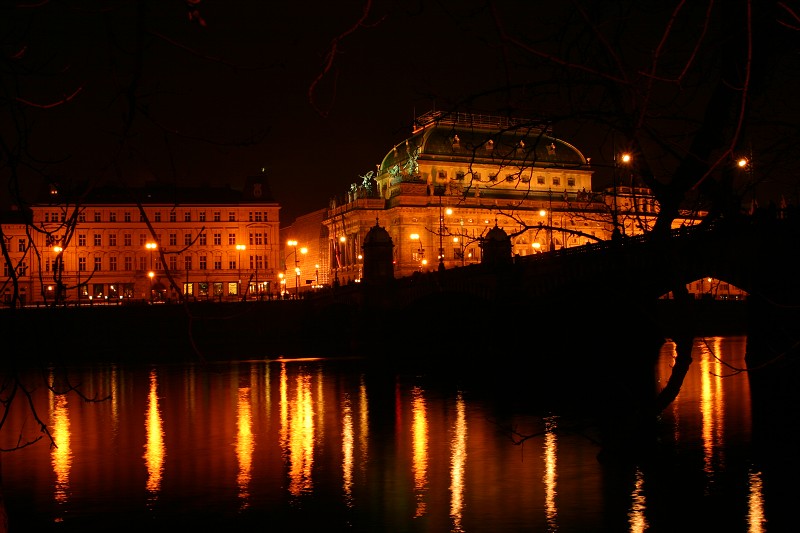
0,175,281,304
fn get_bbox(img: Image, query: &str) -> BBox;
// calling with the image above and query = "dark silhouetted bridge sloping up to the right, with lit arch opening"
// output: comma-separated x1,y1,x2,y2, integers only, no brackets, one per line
308,216,800,364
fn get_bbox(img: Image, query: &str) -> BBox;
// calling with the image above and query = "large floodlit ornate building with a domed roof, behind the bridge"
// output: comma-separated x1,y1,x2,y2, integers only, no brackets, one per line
323,112,657,283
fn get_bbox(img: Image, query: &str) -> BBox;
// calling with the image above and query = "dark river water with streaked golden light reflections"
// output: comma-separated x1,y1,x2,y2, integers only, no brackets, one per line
0,337,797,533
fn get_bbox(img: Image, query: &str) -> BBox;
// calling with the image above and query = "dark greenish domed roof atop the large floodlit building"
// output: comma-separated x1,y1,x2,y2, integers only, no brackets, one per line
380,112,587,174
